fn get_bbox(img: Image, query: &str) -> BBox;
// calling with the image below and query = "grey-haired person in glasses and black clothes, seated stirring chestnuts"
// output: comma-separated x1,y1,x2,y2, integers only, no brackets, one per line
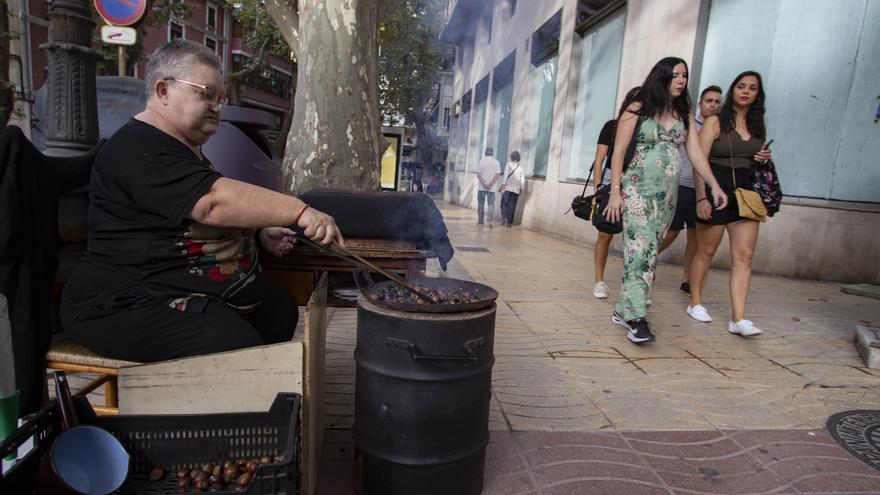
61,39,343,362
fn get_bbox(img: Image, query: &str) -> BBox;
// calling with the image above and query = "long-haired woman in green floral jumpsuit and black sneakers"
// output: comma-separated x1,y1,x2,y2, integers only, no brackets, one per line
605,57,727,343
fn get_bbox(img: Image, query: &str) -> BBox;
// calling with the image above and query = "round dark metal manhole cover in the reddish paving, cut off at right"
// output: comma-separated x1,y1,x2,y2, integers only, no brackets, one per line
827,411,880,470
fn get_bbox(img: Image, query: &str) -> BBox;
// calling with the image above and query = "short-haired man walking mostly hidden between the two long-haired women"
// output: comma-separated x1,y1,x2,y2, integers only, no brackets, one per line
660,86,721,294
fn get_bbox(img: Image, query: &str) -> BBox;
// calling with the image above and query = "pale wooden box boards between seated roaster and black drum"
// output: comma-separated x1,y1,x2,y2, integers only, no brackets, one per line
113,274,327,495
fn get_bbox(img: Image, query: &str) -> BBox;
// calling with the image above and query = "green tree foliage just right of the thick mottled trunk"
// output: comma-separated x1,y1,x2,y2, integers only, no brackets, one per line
379,0,452,122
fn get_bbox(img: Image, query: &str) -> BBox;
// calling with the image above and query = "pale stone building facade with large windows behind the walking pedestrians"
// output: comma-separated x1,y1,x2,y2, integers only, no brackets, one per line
441,0,880,284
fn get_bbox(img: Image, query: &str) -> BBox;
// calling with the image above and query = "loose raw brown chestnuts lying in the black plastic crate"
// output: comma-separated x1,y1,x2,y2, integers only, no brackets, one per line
150,455,284,493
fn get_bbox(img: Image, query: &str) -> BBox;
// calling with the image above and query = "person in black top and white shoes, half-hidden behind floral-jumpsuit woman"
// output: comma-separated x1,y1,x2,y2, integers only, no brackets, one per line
593,86,640,299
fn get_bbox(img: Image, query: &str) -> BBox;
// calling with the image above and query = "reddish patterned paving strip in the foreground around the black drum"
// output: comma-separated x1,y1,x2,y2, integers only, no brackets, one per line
317,430,880,495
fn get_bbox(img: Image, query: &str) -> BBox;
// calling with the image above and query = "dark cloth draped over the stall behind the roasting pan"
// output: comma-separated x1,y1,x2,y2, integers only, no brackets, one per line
300,188,455,271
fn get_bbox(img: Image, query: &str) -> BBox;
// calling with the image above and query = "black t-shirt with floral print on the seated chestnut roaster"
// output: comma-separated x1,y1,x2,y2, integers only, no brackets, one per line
73,119,264,312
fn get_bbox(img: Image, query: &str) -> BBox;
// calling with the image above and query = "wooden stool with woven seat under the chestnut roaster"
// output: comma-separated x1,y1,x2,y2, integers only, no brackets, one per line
46,335,141,416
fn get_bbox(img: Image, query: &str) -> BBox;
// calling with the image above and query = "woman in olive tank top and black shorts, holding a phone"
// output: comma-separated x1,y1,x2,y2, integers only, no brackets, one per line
687,71,772,337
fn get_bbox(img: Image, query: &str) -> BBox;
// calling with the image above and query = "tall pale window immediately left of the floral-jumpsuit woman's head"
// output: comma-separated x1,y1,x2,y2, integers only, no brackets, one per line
559,9,625,180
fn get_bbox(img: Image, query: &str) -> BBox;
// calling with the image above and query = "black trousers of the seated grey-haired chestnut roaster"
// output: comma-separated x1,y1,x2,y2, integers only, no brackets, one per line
61,280,299,363
